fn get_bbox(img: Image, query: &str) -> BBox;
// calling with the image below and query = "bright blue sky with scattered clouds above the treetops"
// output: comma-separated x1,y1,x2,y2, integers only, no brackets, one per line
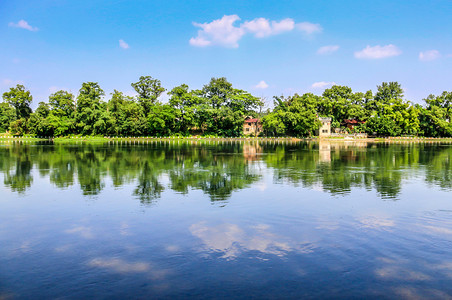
0,0,452,107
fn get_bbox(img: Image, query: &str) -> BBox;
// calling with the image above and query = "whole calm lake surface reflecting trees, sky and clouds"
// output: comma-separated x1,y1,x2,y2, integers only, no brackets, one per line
0,141,452,299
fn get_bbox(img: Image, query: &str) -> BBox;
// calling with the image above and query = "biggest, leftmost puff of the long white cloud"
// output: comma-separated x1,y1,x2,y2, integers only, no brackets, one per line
190,15,245,48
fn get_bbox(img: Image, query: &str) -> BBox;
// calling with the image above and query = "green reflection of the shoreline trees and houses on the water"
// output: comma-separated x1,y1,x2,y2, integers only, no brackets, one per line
0,140,452,204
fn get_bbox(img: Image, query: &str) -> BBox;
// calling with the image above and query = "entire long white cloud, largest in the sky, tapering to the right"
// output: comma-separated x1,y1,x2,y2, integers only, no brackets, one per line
189,15,322,48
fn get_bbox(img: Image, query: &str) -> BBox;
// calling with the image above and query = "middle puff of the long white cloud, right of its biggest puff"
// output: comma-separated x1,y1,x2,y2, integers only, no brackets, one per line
240,18,295,38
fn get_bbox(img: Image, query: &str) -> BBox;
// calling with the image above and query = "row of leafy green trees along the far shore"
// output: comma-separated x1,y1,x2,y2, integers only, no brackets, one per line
0,76,452,137
